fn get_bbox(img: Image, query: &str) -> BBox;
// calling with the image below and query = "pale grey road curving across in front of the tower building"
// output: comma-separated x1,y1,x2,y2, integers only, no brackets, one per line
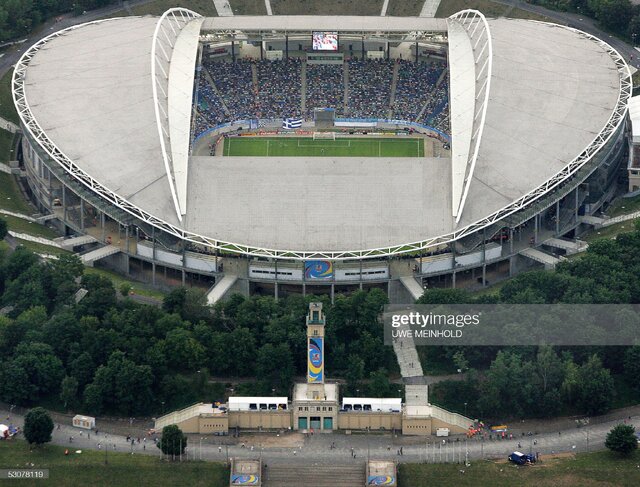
0,408,640,467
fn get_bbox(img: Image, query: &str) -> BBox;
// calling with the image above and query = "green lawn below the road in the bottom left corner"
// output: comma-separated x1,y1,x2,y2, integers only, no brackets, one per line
0,440,229,487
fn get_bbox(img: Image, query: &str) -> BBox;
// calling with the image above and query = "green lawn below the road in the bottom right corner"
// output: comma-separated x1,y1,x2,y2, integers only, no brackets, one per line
398,451,640,487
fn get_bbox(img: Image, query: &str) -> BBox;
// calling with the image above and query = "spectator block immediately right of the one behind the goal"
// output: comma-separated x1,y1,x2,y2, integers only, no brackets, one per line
348,59,395,118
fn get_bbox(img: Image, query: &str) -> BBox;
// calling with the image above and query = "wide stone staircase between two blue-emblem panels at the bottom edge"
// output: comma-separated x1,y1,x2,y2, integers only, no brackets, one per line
262,466,365,487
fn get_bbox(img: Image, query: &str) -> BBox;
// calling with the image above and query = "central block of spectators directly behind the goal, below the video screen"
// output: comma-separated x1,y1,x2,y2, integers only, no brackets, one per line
306,64,344,119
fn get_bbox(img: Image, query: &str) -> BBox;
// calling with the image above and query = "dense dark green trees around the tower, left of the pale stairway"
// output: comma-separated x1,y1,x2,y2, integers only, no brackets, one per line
0,247,397,415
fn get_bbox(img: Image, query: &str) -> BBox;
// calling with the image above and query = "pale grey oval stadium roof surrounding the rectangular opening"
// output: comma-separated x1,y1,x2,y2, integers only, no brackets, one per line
14,10,628,258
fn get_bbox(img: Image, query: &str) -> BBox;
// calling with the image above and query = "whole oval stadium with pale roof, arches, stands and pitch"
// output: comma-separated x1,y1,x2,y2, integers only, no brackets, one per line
12,9,631,302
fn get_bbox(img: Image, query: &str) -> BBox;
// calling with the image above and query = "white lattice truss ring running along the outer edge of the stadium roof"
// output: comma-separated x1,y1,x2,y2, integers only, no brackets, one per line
11,14,632,260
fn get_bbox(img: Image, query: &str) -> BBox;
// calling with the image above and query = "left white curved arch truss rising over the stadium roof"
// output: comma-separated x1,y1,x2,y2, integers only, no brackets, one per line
151,8,203,222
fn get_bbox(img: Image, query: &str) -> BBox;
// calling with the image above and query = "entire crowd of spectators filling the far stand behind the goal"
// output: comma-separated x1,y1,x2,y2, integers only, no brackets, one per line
193,58,450,136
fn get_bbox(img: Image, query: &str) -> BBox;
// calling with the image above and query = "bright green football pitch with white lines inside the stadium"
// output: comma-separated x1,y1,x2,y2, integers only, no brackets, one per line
223,136,424,157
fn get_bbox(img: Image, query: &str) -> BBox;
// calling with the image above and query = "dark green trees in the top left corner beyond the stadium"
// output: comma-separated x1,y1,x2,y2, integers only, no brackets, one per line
0,0,120,42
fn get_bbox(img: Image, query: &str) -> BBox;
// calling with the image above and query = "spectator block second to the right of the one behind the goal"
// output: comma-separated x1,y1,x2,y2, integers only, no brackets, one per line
392,60,446,120
